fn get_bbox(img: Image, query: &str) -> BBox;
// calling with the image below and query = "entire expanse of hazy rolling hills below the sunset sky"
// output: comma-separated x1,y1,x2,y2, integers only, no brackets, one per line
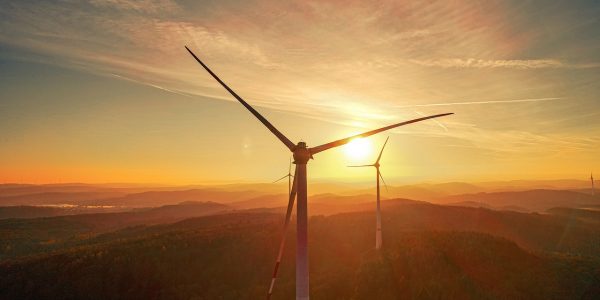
0,183,600,299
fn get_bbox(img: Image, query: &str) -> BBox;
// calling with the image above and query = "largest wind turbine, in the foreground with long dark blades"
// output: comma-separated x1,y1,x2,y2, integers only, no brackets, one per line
185,46,453,300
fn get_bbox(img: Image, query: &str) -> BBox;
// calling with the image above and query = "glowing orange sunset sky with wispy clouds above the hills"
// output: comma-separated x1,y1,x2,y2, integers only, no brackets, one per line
0,0,600,185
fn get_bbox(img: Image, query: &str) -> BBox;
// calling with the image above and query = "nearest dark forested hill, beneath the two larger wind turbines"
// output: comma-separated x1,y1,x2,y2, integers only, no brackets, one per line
0,207,600,299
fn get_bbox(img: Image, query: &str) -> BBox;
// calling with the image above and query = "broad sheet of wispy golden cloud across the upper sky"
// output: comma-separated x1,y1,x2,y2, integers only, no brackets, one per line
0,0,600,159
